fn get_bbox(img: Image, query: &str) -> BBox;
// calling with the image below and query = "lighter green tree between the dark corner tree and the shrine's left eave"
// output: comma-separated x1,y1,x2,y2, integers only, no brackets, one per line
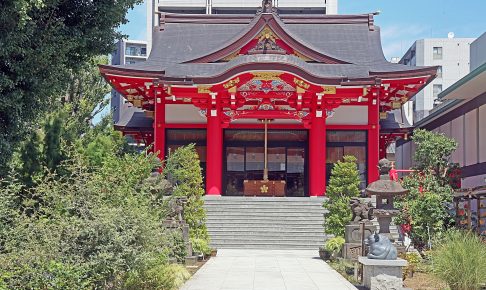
12,57,113,182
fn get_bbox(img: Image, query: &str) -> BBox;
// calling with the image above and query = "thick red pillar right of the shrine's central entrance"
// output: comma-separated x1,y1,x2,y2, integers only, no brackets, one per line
309,103,326,196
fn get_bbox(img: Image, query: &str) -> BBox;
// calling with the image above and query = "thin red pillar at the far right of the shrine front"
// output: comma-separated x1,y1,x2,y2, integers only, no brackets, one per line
368,88,380,183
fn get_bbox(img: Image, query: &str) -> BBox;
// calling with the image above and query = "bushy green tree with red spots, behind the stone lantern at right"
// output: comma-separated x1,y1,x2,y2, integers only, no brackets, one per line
395,129,457,249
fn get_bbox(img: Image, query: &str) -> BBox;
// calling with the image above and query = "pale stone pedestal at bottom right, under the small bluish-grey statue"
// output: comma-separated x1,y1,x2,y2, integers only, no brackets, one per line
358,257,407,289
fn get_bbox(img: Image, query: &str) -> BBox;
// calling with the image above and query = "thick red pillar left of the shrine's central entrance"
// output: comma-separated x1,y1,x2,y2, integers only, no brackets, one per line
206,93,223,195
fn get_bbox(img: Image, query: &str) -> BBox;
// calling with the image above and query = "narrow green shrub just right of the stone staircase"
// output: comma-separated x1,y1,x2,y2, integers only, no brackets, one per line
324,156,360,236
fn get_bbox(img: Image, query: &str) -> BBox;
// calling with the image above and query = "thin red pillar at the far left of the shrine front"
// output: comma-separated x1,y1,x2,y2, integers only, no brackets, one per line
153,87,165,161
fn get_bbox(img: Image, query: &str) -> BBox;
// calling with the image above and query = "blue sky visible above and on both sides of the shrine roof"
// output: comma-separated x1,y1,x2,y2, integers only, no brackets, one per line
121,0,486,59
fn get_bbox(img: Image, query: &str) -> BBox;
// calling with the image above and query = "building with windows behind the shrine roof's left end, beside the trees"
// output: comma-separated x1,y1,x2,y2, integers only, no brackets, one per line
111,39,148,123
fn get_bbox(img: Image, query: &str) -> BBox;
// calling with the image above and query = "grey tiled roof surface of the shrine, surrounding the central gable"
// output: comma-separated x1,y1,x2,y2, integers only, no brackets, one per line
109,11,426,78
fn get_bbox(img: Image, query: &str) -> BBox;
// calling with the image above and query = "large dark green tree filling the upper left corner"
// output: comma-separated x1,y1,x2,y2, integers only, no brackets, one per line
0,0,142,176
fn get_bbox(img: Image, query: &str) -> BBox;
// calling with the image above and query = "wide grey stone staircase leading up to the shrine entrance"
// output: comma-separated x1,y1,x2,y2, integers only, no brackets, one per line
204,196,325,250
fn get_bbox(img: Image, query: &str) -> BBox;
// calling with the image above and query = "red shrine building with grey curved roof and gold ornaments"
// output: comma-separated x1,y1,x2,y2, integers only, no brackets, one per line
100,1,437,196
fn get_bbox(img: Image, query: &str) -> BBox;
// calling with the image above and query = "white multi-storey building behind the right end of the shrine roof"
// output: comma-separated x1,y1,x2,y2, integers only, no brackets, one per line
400,37,474,123
